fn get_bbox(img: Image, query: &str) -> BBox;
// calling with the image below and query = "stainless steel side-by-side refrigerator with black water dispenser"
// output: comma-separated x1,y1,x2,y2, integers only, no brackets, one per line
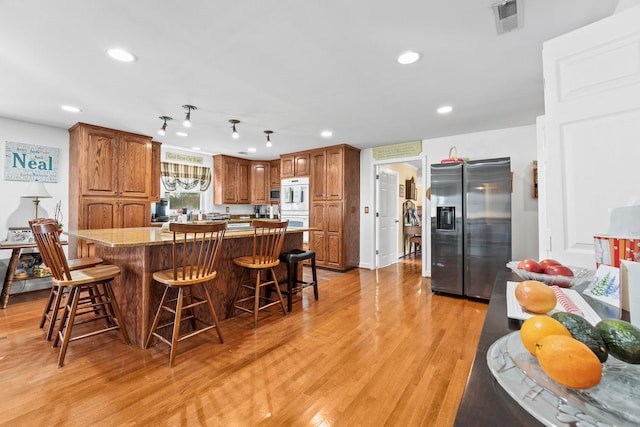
431,157,511,299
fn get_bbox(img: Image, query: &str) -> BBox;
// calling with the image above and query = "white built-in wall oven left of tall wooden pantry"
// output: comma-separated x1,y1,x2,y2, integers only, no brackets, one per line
280,177,310,244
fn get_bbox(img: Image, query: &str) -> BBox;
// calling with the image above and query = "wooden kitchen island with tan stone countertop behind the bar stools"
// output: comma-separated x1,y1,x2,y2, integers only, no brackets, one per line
66,227,308,347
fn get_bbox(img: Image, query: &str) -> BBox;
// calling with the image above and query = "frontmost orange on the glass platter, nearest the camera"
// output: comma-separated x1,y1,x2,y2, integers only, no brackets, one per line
536,335,602,389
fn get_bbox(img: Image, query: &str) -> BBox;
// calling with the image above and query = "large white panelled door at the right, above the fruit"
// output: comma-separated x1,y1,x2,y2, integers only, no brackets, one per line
538,6,640,269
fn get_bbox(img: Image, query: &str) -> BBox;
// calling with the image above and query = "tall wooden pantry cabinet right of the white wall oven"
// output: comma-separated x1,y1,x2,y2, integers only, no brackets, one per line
309,145,360,270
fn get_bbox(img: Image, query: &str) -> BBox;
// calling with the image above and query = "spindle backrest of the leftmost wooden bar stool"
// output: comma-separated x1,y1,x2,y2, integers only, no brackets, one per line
29,218,71,280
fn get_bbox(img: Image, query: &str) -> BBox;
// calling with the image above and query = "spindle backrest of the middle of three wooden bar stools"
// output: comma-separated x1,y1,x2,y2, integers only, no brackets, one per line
169,222,227,282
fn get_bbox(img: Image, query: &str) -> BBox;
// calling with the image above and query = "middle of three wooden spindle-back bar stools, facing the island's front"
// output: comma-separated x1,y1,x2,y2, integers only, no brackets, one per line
144,222,227,367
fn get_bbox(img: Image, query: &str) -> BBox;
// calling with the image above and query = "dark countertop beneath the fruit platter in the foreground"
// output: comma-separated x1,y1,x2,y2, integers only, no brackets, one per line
454,271,628,427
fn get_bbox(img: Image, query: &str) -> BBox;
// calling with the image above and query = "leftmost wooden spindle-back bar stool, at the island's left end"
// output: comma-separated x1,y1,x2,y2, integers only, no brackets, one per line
31,222,129,367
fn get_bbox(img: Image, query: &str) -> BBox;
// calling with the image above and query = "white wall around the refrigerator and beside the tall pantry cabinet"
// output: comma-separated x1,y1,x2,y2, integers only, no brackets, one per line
360,125,538,275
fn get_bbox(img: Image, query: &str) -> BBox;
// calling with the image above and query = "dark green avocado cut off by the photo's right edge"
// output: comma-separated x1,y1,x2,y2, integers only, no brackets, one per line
596,319,640,365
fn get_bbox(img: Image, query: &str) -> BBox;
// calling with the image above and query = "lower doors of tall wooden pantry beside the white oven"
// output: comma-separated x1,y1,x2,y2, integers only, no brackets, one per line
309,202,342,270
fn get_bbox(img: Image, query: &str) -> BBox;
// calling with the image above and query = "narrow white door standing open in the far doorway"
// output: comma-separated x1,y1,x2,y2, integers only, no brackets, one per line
376,166,400,268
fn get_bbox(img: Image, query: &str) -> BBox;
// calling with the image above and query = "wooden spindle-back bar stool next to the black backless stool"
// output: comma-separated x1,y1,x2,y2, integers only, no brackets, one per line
233,219,289,329
